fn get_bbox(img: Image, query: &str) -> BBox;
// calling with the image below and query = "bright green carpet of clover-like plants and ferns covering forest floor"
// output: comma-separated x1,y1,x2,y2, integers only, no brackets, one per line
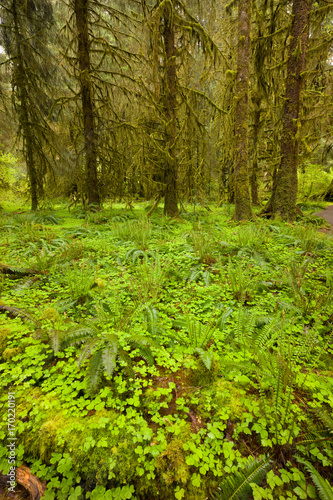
0,203,333,500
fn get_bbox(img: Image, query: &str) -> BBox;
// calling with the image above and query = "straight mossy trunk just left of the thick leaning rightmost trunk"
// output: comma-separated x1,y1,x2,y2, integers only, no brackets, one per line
234,0,253,220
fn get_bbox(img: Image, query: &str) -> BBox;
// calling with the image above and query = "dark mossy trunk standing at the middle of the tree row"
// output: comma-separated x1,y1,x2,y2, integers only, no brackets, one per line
163,4,179,217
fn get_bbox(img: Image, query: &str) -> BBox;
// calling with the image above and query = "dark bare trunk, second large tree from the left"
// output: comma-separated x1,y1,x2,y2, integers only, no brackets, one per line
74,0,100,205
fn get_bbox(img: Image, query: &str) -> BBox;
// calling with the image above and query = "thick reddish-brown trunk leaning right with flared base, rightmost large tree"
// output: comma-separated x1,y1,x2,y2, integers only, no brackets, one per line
264,0,313,221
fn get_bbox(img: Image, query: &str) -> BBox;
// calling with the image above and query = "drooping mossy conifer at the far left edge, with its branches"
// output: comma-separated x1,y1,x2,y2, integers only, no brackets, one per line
0,0,54,210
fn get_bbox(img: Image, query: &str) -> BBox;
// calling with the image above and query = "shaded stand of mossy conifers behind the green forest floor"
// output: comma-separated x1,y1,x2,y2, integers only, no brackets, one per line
0,0,333,220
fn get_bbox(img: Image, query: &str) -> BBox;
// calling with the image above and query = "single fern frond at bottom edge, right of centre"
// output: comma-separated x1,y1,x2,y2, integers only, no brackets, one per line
212,457,271,500
